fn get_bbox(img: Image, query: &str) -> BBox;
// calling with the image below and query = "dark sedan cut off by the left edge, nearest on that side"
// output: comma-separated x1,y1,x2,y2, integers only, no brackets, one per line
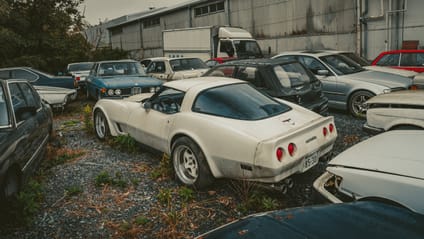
0,80,52,201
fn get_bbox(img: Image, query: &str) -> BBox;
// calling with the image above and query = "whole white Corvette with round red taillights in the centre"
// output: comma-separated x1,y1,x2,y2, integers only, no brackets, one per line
93,77,337,188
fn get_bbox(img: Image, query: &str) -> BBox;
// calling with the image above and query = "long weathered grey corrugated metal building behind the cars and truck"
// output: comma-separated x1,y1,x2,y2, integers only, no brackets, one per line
97,0,424,59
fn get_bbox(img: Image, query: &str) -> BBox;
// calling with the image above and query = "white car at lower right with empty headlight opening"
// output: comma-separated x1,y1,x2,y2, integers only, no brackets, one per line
314,130,424,213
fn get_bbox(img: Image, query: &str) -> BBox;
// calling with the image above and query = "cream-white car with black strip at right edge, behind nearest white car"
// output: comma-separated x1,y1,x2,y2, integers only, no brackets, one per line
364,90,424,131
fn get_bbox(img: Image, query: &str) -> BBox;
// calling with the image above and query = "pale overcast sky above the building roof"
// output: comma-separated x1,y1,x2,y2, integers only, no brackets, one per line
80,0,187,25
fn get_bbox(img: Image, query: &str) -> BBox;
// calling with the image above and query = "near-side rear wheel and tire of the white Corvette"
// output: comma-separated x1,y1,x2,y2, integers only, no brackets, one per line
171,137,214,189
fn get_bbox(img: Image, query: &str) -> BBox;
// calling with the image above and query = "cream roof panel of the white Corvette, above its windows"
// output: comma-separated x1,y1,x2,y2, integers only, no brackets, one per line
163,76,246,92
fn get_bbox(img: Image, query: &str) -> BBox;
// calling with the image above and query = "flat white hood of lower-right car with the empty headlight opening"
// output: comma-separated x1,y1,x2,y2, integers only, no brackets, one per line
327,130,424,179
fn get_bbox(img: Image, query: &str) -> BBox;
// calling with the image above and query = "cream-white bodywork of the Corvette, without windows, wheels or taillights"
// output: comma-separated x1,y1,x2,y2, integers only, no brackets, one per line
94,77,337,183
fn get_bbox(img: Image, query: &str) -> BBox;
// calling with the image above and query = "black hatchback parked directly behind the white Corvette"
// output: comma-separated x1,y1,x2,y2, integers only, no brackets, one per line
203,59,328,115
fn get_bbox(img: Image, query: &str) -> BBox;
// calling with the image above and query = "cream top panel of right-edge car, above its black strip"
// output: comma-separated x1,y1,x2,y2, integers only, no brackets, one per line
367,90,424,105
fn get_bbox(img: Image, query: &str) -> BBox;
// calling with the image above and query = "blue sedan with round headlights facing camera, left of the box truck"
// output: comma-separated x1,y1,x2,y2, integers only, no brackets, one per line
86,60,163,100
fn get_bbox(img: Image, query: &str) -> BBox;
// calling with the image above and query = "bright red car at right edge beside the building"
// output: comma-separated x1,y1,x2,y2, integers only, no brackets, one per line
371,50,424,72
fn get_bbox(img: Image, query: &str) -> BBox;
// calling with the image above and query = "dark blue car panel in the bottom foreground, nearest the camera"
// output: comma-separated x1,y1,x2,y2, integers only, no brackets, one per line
198,199,424,239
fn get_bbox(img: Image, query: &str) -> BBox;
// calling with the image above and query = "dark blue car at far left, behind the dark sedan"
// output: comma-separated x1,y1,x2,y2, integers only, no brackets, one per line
0,67,76,89
